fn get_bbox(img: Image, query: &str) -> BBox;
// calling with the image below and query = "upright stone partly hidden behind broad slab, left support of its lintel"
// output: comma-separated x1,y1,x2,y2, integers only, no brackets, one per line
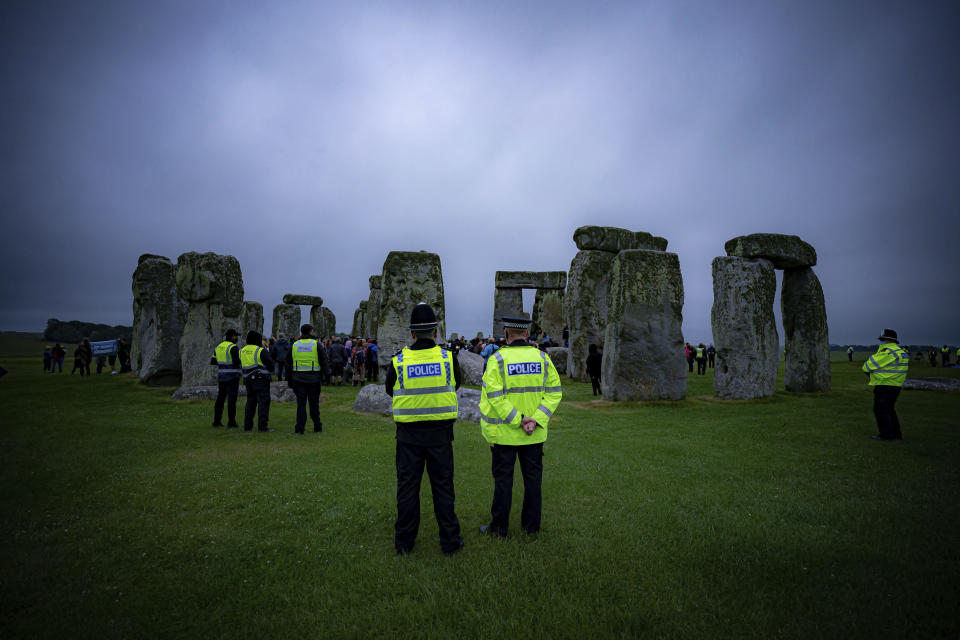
563,251,616,382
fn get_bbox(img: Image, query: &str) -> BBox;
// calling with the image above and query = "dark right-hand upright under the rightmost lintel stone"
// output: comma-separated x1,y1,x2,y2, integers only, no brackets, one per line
780,267,830,392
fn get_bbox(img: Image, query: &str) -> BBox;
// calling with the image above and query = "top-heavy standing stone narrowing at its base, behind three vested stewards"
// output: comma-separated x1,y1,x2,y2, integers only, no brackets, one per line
176,251,243,387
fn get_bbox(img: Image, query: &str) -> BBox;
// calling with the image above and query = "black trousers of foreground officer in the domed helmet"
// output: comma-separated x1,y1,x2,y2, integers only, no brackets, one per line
393,440,463,551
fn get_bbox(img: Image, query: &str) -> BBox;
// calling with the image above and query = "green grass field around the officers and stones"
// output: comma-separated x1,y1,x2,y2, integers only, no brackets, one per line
0,335,960,638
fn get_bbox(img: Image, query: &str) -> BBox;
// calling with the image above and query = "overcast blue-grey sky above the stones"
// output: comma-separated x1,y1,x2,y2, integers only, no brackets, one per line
0,0,960,343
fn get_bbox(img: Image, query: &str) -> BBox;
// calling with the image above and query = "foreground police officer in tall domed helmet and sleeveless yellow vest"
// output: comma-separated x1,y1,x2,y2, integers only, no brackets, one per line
385,302,463,555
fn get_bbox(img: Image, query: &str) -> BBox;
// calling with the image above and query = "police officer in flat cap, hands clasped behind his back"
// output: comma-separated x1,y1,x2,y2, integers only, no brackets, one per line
480,317,563,537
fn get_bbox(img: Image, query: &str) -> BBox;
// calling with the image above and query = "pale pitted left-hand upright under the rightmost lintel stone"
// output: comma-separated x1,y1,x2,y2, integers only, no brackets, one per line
712,256,779,399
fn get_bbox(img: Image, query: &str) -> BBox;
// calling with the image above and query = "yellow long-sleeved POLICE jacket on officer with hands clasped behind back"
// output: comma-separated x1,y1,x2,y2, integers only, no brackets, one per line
479,345,563,445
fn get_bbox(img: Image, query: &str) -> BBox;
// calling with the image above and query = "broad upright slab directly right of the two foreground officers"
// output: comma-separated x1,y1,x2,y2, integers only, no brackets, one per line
602,249,687,401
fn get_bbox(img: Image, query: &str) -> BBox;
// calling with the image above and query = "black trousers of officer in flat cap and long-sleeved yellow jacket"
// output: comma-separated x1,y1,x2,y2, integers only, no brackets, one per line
490,442,543,536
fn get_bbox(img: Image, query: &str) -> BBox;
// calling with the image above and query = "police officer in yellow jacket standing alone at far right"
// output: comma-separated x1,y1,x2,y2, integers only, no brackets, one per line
863,329,910,440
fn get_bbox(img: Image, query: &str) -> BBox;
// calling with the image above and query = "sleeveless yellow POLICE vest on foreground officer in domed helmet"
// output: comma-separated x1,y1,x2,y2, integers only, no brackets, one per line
390,346,458,422
